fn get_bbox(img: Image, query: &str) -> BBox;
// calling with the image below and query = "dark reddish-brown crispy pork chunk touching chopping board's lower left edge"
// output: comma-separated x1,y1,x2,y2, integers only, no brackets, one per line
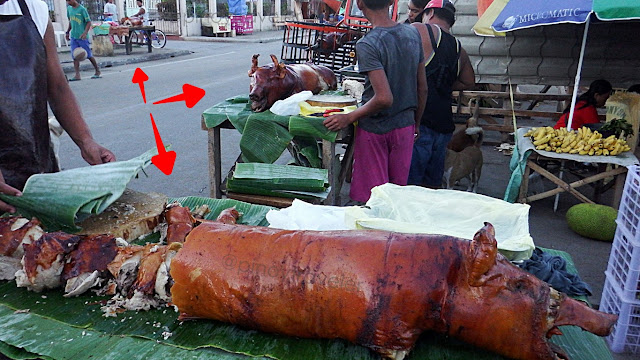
62,235,118,281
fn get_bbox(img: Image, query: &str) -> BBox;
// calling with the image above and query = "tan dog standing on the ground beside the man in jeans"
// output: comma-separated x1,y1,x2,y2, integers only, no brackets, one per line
442,146,483,192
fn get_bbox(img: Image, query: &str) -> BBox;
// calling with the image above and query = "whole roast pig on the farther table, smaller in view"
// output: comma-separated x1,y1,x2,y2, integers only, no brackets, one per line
249,54,338,112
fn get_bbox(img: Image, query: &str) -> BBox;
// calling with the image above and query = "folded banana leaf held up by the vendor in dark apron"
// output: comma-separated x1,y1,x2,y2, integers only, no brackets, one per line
0,149,158,232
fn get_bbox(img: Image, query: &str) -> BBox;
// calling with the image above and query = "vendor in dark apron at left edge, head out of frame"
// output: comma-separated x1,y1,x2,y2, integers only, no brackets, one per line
0,0,115,212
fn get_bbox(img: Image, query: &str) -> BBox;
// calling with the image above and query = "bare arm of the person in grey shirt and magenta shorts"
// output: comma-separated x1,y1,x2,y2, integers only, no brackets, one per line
323,67,392,131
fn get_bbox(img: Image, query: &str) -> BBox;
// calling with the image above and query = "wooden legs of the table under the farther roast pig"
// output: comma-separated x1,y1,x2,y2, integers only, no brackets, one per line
202,116,353,205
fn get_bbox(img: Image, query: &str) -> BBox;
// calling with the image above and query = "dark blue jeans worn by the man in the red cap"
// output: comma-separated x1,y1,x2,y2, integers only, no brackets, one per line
408,125,453,187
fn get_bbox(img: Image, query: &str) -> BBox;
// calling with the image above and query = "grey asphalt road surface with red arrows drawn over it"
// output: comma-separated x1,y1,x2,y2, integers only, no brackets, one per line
55,41,281,197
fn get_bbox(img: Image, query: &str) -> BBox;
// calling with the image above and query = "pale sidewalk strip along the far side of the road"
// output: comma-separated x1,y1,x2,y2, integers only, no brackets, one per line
58,30,283,74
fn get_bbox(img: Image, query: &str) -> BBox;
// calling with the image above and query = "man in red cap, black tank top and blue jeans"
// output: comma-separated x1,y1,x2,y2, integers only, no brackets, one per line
408,0,475,188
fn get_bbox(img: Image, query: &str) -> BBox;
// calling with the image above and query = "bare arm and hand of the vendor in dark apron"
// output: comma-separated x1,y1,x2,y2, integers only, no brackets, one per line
44,21,116,165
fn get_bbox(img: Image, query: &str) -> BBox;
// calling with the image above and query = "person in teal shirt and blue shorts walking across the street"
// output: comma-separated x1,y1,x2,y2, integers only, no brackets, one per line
65,0,100,81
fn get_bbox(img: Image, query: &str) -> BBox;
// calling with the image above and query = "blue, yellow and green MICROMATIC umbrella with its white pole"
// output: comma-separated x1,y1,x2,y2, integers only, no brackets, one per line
473,0,640,129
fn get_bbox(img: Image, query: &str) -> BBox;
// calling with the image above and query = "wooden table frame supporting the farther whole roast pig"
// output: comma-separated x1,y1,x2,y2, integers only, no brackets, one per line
201,97,353,205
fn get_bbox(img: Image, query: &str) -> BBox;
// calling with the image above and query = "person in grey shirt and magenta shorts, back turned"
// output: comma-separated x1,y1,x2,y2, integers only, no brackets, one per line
324,0,427,202
